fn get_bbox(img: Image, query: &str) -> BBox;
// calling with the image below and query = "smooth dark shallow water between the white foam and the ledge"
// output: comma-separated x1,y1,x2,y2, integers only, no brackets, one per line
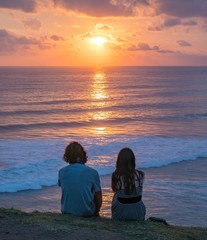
0,158,207,227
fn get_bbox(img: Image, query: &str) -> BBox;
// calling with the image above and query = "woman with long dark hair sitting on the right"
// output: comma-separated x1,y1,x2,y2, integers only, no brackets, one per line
111,148,146,220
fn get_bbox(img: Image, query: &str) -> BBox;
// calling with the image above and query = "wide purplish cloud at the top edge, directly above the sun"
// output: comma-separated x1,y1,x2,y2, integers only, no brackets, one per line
53,0,148,17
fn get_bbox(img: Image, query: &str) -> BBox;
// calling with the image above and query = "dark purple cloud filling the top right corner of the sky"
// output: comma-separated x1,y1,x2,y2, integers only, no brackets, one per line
155,0,207,18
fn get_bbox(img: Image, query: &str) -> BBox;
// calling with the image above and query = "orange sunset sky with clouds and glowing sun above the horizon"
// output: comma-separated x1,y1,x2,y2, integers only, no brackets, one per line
0,0,207,66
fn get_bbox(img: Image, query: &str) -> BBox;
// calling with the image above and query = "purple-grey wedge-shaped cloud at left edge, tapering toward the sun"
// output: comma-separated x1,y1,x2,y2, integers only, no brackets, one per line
0,29,51,55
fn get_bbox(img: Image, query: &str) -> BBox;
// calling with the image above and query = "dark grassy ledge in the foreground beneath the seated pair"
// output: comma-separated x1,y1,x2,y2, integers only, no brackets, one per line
0,208,207,240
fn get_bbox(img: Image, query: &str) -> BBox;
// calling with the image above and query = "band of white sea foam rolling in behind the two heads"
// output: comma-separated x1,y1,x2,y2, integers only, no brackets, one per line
0,136,207,192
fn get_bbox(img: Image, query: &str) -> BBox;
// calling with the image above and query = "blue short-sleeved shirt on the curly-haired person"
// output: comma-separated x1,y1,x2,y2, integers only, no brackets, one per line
58,163,101,216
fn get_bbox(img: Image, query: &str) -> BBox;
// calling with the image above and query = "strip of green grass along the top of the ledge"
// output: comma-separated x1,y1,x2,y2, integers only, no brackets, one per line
0,208,207,240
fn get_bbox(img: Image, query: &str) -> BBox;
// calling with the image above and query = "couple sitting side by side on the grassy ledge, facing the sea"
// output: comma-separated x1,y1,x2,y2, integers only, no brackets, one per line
58,142,146,220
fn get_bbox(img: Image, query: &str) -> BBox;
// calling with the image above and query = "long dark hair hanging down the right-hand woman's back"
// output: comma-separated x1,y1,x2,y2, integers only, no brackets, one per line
112,148,144,195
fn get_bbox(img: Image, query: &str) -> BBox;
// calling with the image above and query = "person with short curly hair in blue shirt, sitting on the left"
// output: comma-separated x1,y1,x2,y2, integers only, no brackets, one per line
58,142,102,217
